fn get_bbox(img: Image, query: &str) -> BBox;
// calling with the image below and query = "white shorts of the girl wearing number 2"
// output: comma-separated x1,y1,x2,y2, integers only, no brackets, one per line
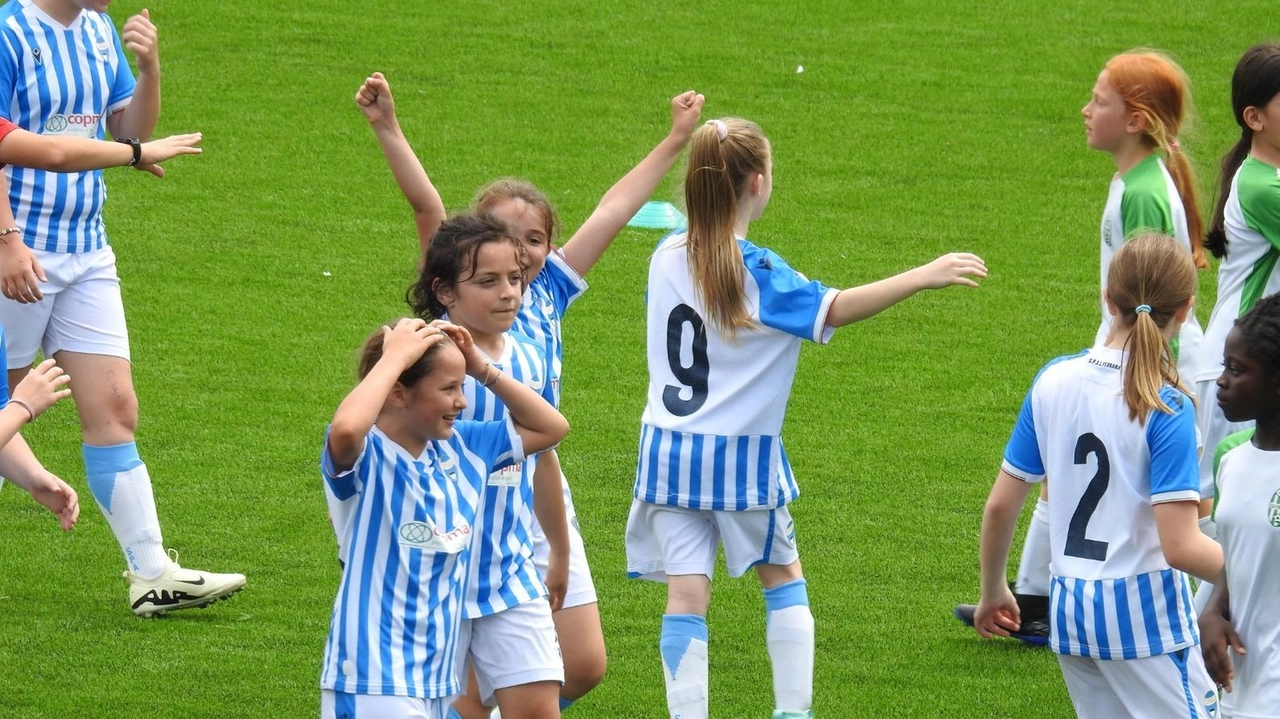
1057,645,1219,719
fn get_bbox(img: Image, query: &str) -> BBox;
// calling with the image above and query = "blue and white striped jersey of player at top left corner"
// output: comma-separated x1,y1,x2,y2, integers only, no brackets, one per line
0,0,134,252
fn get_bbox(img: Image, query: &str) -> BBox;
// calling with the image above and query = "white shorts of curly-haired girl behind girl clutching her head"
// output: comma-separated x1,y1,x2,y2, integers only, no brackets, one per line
466,597,564,706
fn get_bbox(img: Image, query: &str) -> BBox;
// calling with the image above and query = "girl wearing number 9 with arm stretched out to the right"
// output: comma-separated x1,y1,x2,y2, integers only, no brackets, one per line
626,118,987,719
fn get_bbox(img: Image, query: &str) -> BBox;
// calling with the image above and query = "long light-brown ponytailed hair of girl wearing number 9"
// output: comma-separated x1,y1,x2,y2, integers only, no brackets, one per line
685,118,769,338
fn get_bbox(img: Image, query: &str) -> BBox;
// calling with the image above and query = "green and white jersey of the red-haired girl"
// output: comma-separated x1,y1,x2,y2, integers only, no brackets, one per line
1094,155,1203,381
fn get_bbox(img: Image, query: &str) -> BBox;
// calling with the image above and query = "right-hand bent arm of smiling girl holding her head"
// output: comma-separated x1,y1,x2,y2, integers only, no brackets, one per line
431,320,568,455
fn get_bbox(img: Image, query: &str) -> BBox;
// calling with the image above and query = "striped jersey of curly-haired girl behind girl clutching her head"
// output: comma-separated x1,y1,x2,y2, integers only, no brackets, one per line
460,331,556,619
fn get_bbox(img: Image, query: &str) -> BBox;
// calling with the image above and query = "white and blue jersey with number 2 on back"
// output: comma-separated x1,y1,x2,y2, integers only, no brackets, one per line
1004,347,1199,659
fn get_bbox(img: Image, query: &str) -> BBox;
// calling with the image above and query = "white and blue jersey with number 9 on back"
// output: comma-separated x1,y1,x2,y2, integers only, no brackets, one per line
635,232,838,510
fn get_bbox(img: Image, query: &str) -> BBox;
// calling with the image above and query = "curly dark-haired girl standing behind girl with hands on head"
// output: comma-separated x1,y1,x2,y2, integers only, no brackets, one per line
408,215,568,719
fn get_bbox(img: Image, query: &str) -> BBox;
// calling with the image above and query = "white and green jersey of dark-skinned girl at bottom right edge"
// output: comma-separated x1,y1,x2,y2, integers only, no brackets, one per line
1213,430,1280,716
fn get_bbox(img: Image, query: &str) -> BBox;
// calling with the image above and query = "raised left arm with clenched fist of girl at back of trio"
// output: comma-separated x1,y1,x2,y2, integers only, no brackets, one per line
356,73,444,257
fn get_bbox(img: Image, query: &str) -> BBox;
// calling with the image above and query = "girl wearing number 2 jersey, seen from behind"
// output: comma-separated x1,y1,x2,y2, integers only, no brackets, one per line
974,235,1222,718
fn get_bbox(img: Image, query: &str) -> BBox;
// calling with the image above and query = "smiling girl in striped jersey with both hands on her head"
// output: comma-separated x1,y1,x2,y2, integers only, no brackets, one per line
320,319,568,719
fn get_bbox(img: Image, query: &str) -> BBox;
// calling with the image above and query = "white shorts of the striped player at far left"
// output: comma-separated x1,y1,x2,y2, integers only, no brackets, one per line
0,246,129,370
